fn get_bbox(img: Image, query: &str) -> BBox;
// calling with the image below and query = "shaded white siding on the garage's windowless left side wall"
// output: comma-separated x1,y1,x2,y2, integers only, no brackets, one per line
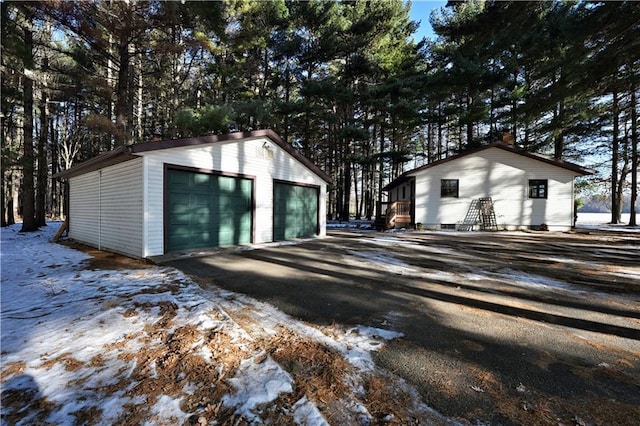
69,159,144,257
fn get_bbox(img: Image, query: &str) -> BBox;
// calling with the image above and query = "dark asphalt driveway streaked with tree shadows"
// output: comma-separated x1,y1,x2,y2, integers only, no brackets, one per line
164,231,640,424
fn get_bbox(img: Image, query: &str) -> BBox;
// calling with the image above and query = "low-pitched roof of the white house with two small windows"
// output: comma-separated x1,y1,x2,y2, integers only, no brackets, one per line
382,142,596,191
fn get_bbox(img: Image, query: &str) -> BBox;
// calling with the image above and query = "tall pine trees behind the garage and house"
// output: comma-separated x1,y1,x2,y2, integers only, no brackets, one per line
0,0,640,231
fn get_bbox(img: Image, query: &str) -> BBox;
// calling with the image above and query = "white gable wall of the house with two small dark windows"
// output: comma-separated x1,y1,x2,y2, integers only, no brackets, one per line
415,148,574,230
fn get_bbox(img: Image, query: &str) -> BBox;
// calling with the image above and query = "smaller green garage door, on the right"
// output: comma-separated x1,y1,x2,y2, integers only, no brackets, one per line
273,182,319,241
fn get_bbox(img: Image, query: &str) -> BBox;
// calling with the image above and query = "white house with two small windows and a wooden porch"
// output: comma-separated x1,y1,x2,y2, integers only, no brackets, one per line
383,142,594,230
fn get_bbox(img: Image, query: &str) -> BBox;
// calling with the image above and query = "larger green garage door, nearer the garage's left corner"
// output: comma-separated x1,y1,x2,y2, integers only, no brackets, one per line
165,170,253,251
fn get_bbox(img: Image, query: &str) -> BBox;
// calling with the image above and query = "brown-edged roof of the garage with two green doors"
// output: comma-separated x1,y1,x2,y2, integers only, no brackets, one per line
53,129,333,183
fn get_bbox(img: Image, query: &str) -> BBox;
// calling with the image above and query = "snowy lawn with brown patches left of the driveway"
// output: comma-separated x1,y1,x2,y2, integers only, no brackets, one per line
1,223,449,425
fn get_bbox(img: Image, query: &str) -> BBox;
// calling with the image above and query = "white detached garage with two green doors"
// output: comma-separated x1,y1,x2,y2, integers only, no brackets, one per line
56,130,331,258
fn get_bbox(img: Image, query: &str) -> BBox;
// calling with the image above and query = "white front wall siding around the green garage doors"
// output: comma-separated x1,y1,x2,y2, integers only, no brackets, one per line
141,138,326,256
